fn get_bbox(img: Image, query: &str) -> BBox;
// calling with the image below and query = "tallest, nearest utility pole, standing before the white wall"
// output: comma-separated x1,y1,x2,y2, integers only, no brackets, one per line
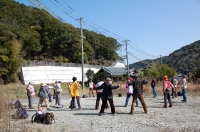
80,17,84,90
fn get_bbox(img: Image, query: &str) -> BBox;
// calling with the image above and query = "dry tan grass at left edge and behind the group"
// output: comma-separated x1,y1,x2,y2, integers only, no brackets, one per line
0,81,200,132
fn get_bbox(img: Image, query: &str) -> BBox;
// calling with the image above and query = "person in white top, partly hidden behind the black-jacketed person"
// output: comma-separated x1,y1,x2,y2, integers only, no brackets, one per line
95,78,108,110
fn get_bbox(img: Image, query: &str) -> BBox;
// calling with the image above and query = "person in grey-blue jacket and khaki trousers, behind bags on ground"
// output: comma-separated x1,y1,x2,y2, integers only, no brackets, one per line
38,83,49,111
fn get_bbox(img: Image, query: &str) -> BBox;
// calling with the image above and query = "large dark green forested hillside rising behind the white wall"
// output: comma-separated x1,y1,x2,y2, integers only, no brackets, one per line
0,0,120,64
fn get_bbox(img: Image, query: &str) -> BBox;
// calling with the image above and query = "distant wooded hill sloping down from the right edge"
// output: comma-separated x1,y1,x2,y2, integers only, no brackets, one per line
129,40,200,72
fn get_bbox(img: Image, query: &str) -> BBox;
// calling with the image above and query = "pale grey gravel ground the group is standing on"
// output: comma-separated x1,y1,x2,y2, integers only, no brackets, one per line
15,96,200,132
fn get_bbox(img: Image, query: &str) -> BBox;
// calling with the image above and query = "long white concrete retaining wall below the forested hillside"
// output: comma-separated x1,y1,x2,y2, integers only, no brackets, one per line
21,66,100,85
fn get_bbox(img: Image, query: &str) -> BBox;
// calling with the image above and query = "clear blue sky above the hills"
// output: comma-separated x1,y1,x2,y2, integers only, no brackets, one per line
16,0,200,64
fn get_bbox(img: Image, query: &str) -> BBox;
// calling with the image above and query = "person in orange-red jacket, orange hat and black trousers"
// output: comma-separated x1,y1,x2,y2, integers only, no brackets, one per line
163,76,174,108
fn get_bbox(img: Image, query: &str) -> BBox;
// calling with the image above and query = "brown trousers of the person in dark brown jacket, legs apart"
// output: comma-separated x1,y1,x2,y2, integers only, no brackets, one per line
130,94,147,113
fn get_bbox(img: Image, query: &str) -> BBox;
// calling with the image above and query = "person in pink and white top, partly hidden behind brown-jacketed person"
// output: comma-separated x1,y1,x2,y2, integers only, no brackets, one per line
124,77,138,107
